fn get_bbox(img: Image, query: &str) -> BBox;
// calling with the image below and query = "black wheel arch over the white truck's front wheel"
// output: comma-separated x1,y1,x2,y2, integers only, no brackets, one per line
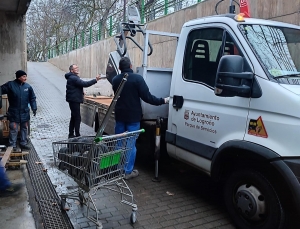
211,141,300,220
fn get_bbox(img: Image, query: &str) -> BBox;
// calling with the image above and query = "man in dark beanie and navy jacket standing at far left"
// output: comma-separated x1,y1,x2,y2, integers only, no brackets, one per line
1,70,37,150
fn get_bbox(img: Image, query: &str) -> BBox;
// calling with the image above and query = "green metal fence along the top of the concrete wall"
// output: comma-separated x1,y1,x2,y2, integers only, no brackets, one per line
48,0,204,59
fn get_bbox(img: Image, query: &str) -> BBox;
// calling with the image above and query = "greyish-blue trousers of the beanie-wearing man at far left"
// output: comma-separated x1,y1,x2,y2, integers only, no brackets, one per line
9,122,28,147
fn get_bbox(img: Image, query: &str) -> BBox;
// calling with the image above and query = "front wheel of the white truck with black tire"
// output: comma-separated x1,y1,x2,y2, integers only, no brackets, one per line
224,169,286,229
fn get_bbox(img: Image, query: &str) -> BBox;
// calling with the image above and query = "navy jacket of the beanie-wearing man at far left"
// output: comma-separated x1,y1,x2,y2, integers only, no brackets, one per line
1,79,37,123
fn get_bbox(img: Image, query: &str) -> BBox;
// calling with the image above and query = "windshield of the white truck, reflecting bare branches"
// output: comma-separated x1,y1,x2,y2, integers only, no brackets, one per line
240,24,300,79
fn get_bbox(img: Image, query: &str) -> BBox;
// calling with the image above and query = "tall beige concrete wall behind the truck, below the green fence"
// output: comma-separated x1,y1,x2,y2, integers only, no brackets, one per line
49,0,300,81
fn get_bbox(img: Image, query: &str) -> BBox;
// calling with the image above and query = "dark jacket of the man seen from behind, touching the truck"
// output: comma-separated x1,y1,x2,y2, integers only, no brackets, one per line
112,69,165,122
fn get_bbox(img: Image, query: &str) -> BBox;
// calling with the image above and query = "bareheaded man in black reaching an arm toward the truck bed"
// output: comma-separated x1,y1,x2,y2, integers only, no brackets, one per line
65,64,100,138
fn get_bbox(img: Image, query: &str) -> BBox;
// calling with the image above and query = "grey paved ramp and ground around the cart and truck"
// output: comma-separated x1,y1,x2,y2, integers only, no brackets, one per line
28,62,234,229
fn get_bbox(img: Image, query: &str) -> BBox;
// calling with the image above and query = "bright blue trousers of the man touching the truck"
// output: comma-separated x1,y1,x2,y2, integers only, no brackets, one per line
115,121,140,174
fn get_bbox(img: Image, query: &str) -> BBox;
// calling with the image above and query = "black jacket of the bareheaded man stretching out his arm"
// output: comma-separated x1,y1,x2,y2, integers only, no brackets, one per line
65,72,97,103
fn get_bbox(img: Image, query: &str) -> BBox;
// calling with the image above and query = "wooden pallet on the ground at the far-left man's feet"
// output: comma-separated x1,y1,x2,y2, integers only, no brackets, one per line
0,147,29,167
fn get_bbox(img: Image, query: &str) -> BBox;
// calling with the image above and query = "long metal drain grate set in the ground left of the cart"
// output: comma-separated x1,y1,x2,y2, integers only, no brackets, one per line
25,142,73,229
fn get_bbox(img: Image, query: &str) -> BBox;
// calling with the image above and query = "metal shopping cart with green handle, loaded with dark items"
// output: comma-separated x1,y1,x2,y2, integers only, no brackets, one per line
52,129,144,229
